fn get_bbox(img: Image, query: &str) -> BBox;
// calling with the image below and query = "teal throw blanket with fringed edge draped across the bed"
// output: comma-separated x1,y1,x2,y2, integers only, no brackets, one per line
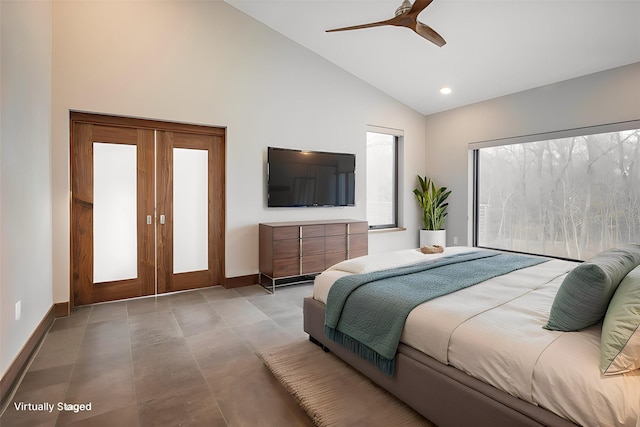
325,251,547,376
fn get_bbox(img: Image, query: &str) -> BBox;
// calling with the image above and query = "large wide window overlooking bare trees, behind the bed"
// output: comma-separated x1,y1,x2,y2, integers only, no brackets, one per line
471,121,640,260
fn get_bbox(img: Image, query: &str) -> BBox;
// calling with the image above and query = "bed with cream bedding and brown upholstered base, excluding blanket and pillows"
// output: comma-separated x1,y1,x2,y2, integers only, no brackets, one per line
304,247,640,427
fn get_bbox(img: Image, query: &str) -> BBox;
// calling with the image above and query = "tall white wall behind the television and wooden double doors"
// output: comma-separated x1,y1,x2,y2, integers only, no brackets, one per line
52,1,425,302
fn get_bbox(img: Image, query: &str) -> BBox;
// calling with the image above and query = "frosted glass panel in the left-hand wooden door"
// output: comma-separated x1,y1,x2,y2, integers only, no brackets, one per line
93,142,138,283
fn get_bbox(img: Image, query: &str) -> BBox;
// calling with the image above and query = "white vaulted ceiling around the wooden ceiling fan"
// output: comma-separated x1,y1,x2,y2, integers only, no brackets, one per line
225,0,640,115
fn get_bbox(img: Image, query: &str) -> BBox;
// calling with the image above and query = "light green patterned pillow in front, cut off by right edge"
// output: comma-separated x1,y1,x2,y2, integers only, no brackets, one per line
600,267,640,375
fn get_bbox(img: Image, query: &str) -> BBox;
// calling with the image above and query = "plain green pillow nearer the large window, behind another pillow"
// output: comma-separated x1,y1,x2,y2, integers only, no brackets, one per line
544,245,640,332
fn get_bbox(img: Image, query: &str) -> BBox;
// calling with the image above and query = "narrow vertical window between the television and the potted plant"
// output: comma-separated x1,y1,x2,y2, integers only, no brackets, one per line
367,129,401,229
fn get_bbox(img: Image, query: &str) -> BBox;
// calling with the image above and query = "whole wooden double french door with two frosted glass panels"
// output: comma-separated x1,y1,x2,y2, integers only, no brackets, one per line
71,113,225,305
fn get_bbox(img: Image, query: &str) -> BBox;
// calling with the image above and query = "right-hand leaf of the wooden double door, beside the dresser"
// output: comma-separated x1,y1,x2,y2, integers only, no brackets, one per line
156,131,224,293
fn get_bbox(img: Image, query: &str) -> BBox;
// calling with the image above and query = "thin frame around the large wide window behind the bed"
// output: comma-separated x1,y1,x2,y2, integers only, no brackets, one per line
468,119,640,261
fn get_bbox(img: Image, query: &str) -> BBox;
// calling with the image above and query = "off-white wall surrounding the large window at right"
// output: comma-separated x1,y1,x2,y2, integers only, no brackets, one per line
426,63,640,244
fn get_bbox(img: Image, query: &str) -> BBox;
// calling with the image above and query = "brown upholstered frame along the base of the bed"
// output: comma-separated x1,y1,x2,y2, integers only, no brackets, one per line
304,297,575,427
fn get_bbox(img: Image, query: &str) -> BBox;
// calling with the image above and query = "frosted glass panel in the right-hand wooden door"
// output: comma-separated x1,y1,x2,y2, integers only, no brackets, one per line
173,148,209,273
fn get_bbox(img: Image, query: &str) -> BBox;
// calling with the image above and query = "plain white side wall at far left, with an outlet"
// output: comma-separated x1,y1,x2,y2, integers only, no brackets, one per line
0,1,53,375
